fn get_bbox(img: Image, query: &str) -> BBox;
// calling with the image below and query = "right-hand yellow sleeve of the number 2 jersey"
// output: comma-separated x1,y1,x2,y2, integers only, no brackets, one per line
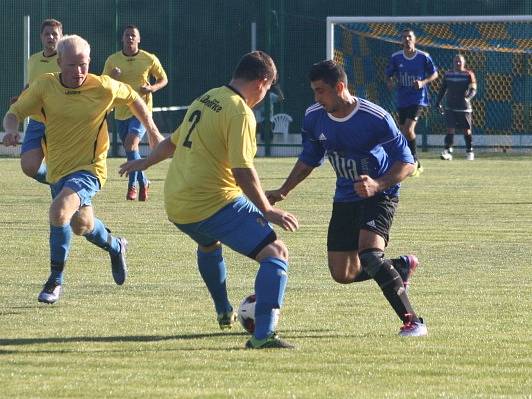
226,114,257,169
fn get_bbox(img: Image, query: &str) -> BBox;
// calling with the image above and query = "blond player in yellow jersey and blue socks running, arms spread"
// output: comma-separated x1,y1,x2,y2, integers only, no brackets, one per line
4,35,163,303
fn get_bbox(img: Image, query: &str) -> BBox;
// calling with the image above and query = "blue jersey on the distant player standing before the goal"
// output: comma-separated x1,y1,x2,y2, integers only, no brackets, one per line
386,50,437,108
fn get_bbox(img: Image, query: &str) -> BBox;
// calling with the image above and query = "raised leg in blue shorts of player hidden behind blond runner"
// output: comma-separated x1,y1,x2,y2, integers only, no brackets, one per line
20,119,48,184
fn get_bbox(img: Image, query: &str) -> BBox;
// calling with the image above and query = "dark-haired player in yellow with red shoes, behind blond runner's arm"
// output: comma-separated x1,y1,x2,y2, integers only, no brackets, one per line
103,25,168,201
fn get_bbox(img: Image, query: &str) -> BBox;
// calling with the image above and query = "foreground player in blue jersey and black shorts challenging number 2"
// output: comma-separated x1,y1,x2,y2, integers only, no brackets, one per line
266,61,427,336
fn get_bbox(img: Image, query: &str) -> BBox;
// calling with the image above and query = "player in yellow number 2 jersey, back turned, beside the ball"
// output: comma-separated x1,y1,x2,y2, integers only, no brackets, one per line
120,51,298,349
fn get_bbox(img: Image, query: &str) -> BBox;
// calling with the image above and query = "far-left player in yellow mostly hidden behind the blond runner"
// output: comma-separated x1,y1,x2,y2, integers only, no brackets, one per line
4,19,63,183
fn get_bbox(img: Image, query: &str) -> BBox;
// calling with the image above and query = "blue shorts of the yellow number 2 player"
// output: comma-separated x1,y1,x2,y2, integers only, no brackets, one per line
175,196,277,259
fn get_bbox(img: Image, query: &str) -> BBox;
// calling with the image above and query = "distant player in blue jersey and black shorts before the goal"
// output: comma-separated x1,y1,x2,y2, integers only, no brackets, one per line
386,29,438,176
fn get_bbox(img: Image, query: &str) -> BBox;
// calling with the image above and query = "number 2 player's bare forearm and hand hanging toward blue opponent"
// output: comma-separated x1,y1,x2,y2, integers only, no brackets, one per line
231,168,299,231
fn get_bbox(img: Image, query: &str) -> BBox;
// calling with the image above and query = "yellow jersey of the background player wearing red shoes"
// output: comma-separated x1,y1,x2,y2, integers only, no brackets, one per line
103,50,167,120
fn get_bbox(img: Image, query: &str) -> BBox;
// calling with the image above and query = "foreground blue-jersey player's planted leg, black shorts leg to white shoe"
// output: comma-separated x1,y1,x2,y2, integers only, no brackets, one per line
358,195,427,336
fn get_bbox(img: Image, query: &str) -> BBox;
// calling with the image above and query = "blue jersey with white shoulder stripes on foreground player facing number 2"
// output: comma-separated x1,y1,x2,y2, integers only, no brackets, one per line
299,98,414,202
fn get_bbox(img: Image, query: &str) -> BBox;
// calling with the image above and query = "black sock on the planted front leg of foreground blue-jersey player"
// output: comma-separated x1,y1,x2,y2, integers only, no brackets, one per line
375,259,419,322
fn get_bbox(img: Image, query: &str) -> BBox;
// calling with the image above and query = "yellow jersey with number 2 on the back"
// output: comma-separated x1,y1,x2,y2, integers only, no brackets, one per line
164,86,257,224
